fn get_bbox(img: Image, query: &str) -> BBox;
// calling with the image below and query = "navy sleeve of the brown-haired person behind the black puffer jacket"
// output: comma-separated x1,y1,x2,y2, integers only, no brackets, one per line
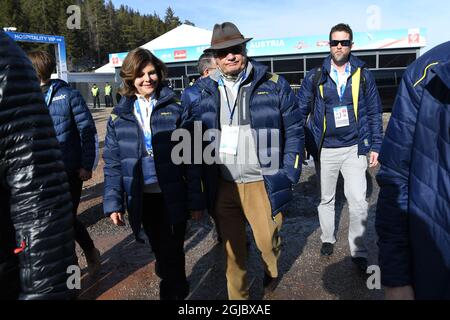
69,90,98,171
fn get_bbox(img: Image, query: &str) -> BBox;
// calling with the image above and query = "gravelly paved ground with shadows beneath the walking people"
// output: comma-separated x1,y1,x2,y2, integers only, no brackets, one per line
77,109,388,300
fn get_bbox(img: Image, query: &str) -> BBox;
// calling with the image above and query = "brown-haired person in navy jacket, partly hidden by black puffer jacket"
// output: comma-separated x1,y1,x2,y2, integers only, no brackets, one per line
28,51,100,275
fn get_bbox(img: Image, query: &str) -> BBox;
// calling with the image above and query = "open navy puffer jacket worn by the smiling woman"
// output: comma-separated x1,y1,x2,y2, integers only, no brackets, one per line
103,87,204,236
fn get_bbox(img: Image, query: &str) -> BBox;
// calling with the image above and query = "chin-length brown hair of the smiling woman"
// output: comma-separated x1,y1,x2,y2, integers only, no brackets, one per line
119,48,167,96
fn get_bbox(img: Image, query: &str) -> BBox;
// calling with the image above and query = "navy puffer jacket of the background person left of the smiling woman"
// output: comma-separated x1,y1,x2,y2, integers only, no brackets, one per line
49,80,98,173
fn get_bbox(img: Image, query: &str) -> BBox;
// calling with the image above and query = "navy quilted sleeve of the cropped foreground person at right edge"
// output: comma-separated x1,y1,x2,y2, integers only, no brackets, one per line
376,69,420,287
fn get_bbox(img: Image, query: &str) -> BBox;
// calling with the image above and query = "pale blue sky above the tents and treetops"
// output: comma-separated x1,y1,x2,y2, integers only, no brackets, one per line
113,0,450,49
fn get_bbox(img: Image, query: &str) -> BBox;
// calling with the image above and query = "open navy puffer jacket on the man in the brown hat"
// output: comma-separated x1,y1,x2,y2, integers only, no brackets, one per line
182,60,304,215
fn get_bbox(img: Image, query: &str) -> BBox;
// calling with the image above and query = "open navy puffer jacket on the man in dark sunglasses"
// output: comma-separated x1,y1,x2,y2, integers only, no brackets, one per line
298,54,383,158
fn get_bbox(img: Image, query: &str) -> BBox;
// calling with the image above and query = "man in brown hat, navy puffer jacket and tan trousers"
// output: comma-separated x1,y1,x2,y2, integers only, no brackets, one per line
182,22,304,300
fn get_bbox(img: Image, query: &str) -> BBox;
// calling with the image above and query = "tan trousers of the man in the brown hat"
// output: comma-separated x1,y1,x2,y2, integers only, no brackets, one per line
215,180,282,300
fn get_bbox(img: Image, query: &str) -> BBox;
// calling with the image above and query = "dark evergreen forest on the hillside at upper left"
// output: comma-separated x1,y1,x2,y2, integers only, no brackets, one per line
0,0,193,71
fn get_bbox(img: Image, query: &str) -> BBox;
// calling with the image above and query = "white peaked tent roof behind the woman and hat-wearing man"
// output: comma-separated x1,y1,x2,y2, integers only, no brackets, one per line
95,24,212,73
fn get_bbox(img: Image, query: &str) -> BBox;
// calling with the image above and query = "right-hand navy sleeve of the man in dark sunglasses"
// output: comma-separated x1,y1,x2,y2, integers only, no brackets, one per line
363,69,383,152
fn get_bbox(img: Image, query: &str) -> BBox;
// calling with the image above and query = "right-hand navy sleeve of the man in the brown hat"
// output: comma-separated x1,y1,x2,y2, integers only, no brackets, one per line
277,77,305,184
